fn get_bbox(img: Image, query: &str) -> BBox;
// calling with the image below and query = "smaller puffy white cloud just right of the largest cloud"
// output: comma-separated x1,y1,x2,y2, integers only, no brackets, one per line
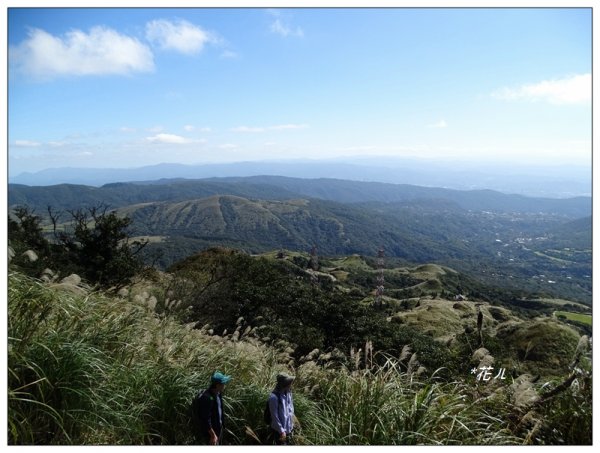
146,19,217,55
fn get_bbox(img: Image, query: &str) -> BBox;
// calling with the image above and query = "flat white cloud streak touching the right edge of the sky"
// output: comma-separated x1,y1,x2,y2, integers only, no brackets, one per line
492,74,592,105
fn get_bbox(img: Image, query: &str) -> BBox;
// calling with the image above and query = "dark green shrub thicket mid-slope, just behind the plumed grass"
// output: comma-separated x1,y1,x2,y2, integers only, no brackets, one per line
170,249,455,369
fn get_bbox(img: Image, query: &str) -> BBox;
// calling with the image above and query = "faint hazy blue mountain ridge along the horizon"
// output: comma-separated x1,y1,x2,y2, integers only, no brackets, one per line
9,157,592,198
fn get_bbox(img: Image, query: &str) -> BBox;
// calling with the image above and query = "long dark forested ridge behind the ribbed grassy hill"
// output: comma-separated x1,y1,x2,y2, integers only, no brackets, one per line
8,176,592,219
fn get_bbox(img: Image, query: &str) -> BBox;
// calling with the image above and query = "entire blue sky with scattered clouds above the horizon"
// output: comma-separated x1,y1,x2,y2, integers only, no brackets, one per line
8,8,592,176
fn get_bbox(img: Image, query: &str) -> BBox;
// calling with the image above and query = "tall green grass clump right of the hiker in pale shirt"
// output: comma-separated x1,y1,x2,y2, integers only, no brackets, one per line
296,357,518,445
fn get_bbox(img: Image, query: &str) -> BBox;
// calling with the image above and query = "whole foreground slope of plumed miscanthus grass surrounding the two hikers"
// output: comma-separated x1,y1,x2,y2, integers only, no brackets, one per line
8,273,552,445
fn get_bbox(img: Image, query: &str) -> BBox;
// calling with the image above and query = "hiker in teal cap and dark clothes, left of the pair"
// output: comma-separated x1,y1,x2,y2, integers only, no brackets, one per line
192,371,231,445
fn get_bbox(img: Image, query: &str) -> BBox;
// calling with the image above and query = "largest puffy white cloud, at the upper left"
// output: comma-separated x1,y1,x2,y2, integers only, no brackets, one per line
9,27,154,79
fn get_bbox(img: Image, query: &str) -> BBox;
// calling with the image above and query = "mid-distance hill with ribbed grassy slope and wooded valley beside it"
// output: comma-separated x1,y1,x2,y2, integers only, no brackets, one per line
118,195,591,304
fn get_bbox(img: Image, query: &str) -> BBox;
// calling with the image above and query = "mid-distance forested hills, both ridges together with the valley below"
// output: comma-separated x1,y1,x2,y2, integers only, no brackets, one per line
8,176,592,303
